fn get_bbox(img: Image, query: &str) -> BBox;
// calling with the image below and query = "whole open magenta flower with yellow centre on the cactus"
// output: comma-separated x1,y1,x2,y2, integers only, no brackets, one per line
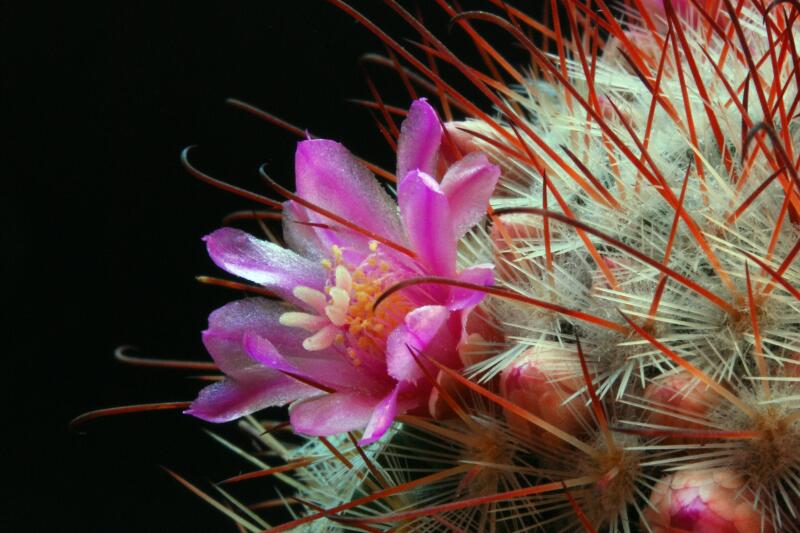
187,99,499,443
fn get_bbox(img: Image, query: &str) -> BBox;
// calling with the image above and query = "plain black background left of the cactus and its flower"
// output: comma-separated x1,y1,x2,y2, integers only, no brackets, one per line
6,0,536,532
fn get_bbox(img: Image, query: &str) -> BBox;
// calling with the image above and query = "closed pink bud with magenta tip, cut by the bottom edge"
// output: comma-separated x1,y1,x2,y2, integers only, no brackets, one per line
645,468,773,533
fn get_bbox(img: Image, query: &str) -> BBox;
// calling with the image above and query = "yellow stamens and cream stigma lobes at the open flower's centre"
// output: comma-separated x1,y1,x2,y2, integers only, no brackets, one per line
280,241,413,366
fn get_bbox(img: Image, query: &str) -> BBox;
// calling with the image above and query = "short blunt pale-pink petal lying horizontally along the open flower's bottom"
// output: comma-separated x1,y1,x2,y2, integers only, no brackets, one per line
289,392,379,437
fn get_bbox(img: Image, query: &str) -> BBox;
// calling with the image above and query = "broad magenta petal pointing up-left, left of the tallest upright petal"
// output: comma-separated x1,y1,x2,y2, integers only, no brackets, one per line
295,139,402,242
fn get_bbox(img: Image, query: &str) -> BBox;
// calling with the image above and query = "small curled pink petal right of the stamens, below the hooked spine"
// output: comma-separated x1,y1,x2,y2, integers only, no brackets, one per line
386,305,455,382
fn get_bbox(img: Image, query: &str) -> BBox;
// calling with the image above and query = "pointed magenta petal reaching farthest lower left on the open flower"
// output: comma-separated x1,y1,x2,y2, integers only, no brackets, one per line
184,368,320,422
